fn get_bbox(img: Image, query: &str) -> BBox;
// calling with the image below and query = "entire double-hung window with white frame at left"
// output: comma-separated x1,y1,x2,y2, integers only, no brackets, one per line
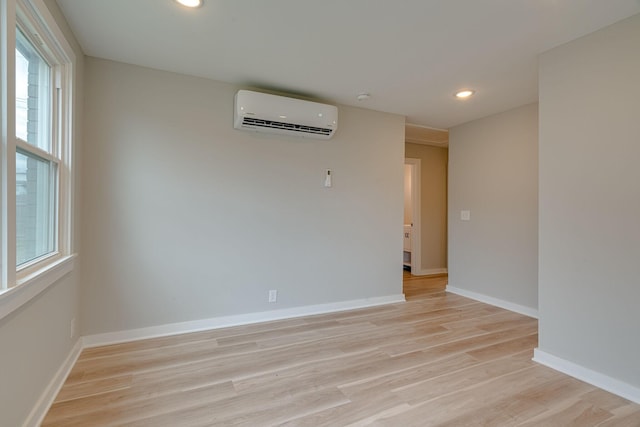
0,0,74,310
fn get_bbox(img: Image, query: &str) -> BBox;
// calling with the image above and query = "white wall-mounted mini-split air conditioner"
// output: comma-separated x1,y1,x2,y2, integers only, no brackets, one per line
233,90,338,139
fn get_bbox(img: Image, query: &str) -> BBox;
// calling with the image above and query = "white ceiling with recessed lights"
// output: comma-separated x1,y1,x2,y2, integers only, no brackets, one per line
58,0,640,129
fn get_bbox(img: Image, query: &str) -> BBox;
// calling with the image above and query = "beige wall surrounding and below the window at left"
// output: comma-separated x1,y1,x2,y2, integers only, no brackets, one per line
0,0,84,426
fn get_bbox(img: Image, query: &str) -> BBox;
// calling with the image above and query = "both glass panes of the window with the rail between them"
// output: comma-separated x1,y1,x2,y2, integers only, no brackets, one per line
15,29,60,267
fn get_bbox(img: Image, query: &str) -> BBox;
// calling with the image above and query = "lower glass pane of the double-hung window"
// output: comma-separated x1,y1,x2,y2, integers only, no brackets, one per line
16,151,56,265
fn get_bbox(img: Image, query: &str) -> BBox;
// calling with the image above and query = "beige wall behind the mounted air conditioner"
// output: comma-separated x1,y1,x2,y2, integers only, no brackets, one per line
82,58,404,334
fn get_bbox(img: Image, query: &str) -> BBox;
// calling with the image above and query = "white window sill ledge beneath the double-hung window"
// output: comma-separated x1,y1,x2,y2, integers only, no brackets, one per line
0,254,76,320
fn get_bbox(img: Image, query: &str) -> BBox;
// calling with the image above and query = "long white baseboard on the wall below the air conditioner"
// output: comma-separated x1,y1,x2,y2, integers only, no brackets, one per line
82,294,405,348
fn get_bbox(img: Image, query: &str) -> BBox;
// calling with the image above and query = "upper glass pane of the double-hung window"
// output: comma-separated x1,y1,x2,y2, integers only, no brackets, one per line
16,30,51,152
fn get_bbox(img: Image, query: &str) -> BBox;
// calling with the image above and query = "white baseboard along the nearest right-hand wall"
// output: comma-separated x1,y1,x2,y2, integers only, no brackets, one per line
533,348,640,404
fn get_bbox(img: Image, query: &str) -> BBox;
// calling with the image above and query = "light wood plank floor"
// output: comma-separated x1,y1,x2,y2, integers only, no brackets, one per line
43,273,640,427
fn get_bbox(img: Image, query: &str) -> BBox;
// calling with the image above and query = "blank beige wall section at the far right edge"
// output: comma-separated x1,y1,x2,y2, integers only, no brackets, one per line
539,15,640,392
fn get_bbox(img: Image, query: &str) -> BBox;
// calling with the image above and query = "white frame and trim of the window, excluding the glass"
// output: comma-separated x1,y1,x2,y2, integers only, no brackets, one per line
0,0,76,319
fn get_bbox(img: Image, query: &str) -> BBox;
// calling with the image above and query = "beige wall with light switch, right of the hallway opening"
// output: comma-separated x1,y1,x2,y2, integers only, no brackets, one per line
449,104,538,313
